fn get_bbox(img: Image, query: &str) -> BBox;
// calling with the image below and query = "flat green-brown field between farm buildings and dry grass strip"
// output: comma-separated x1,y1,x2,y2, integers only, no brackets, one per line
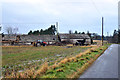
2,46,90,76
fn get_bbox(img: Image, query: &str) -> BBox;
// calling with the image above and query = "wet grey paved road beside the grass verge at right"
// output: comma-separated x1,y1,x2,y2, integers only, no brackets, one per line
79,44,120,80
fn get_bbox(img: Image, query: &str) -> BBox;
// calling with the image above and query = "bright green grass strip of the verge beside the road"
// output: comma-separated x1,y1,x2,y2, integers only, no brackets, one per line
38,45,108,78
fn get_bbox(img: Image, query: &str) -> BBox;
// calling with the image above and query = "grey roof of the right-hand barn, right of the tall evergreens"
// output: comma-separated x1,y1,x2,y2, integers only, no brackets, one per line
59,34,90,39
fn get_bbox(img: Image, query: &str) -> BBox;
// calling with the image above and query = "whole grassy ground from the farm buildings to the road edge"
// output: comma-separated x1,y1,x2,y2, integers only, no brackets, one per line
2,45,108,78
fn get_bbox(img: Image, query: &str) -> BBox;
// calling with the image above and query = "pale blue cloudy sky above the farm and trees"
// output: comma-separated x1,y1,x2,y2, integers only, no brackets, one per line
0,0,119,35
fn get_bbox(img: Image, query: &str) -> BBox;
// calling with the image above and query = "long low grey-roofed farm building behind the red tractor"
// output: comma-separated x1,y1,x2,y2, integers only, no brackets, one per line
2,35,57,45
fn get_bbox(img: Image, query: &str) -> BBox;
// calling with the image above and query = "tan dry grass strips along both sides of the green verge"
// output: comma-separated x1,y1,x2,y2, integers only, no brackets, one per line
4,46,108,78
